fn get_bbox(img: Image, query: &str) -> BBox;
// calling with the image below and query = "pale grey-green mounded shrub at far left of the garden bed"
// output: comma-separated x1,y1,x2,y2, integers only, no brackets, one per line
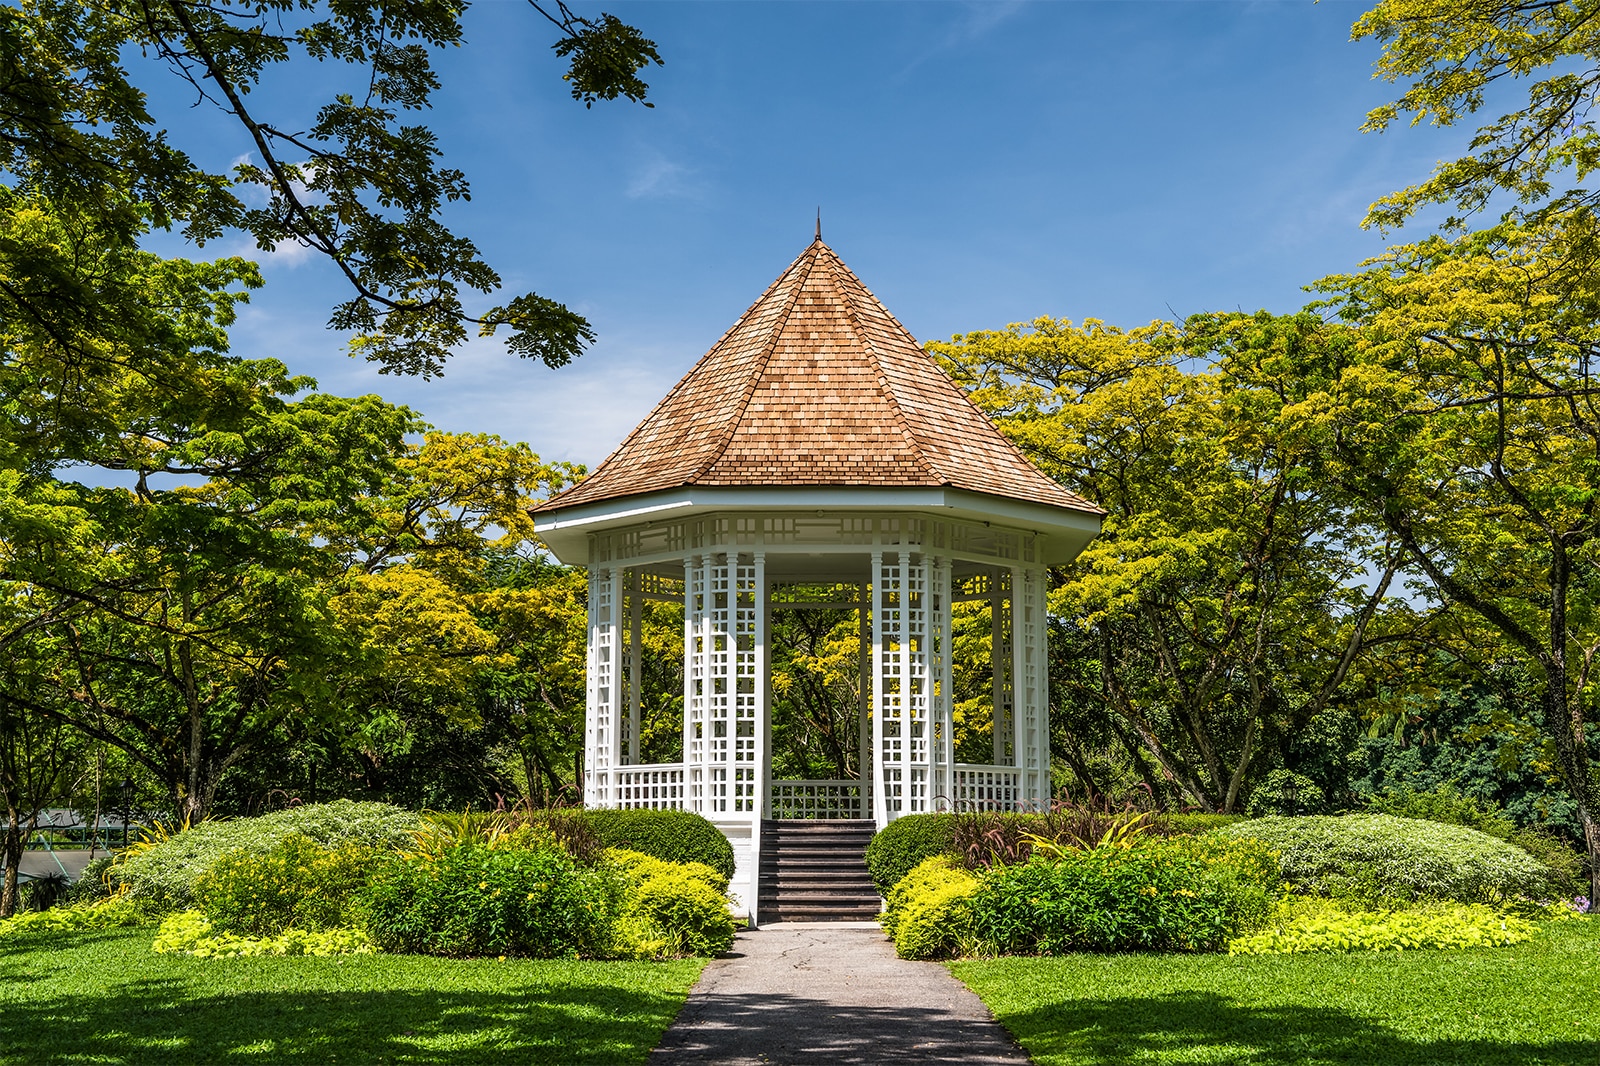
115,800,422,909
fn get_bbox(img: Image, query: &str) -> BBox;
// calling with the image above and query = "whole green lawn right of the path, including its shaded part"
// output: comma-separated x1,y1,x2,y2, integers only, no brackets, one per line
950,919,1600,1066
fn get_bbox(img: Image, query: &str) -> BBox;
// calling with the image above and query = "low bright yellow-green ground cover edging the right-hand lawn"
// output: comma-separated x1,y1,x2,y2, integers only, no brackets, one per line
1227,896,1534,956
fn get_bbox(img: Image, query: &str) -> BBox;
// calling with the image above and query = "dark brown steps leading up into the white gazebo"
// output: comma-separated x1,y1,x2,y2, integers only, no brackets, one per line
757,818,882,924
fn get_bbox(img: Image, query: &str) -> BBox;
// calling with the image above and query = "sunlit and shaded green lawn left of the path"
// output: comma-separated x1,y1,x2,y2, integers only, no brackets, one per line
0,928,704,1064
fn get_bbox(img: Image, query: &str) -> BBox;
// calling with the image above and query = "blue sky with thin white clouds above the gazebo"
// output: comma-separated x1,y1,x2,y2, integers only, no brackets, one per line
154,0,1466,466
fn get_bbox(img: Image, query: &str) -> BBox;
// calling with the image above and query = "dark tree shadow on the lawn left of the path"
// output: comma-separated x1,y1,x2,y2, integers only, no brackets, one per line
0,940,682,1066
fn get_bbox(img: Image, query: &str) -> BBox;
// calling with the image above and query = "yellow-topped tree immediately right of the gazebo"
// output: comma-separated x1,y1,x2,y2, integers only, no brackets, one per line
928,317,1403,812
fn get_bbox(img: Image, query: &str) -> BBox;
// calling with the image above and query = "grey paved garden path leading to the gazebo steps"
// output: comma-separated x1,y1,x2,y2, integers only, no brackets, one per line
650,922,1029,1066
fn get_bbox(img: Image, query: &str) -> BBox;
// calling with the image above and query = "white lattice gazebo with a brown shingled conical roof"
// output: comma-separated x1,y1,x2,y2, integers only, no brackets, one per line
534,234,1102,917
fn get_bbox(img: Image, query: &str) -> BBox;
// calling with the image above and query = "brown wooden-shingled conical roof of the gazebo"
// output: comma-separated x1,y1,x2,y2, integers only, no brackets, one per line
534,237,1099,514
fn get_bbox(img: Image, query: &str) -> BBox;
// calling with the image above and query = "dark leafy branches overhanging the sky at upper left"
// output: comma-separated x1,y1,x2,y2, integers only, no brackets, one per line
0,0,661,376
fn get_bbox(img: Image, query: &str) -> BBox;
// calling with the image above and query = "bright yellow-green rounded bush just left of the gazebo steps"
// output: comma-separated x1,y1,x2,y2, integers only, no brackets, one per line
606,848,734,959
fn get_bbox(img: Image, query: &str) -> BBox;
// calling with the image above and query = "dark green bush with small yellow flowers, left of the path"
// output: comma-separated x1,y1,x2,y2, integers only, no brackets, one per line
358,845,627,959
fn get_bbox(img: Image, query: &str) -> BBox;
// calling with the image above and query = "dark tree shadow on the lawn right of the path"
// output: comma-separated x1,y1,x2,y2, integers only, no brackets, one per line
1003,992,1600,1066
